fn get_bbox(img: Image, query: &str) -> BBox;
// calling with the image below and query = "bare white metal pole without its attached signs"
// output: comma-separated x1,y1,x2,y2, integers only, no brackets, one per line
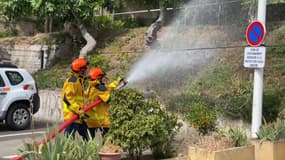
251,0,266,138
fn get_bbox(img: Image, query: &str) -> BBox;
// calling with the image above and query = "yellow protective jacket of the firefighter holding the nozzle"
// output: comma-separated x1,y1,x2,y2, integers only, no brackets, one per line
85,80,119,128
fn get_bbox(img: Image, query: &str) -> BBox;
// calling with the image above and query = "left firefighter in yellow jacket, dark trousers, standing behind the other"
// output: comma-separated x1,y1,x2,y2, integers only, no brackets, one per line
61,58,88,140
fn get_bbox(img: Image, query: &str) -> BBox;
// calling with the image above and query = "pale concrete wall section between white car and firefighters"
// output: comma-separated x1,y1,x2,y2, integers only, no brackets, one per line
34,90,63,122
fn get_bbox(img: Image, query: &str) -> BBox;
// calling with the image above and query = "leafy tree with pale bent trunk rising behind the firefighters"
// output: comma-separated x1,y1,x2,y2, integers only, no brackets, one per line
31,0,104,57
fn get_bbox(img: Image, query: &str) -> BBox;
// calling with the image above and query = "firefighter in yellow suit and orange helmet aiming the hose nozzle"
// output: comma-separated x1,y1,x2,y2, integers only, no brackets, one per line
85,68,126,138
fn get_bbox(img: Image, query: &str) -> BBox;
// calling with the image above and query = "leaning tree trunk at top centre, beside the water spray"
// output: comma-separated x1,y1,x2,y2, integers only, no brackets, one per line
145,6,166,46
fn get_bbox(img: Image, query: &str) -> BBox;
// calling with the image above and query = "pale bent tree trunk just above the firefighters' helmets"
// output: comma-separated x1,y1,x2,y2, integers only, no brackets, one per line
72,11,96,58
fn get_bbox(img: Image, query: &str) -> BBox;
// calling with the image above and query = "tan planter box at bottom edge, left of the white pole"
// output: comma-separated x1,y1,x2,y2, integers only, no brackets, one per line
188,145,254,160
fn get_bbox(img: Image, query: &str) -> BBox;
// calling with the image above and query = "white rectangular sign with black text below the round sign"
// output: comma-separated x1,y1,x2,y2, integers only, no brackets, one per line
243,47,266,68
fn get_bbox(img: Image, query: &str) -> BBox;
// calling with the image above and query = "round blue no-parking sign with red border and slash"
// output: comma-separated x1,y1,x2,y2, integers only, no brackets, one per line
246,21,265,47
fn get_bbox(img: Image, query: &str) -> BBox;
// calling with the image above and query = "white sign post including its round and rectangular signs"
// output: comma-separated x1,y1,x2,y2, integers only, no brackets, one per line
244,0,266,138
